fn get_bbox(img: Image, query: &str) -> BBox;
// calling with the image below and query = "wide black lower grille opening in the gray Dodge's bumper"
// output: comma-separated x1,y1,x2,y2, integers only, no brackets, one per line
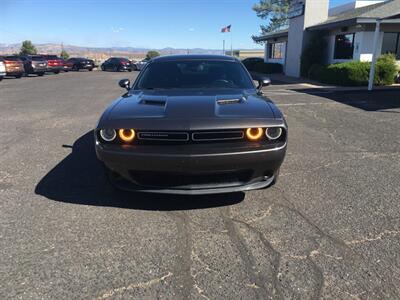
129,170,253,189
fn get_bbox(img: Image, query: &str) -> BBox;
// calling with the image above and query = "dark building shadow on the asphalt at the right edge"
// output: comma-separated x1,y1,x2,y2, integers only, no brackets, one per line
292,89,400,113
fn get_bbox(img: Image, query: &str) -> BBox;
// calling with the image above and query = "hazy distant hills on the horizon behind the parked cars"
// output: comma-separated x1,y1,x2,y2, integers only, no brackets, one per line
0,43,262,60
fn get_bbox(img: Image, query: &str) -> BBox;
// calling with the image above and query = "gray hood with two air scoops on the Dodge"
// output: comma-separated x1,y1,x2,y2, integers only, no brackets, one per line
102,90,282,130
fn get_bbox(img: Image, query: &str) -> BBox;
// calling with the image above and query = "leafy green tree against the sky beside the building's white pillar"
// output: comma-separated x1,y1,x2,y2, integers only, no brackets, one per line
253,0,290,38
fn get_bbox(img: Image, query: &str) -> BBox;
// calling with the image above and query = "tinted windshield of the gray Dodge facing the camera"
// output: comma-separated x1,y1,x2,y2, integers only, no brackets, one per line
135,60,254,89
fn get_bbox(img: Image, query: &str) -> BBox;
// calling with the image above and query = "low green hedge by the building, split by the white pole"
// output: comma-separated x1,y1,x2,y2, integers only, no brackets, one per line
308,55,397,86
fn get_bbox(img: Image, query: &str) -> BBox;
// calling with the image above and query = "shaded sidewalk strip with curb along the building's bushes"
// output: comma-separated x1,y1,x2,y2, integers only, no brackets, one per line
268,74,400,92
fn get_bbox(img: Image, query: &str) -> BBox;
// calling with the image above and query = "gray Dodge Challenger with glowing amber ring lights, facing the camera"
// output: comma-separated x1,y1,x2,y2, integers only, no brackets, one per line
94,55,288,194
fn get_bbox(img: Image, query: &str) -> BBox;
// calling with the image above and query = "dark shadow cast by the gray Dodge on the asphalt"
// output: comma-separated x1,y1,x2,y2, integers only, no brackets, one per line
35,131,244,211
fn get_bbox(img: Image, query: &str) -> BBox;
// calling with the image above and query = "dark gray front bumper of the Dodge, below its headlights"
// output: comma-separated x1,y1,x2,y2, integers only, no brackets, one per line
95,141,286,194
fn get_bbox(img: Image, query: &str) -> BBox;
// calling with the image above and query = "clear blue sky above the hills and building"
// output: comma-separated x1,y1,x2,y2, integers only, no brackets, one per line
0,0,351,49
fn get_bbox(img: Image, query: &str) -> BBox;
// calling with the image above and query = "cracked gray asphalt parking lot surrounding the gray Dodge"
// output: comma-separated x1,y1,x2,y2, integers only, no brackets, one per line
0,71,400,299
